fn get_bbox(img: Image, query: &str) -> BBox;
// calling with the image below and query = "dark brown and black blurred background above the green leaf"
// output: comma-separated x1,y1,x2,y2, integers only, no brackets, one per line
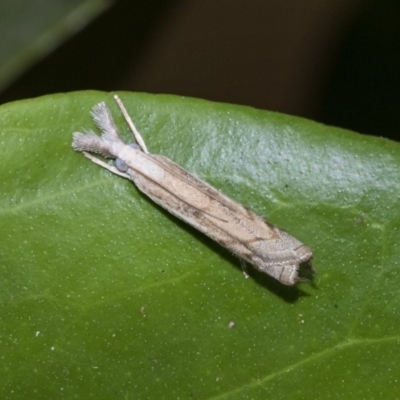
0,0,400,140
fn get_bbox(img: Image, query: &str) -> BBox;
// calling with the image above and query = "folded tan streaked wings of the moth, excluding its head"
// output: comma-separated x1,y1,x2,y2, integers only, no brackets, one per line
128,155,312,285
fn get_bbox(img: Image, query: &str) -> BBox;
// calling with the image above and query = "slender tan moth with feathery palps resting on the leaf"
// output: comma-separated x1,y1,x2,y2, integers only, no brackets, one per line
72,96,314,286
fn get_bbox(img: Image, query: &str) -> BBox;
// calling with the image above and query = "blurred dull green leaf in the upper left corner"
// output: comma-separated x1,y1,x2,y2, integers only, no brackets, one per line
0,0,113,90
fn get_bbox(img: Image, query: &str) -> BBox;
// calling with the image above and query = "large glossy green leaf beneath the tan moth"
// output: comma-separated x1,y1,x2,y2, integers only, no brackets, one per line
0,92,400,399
